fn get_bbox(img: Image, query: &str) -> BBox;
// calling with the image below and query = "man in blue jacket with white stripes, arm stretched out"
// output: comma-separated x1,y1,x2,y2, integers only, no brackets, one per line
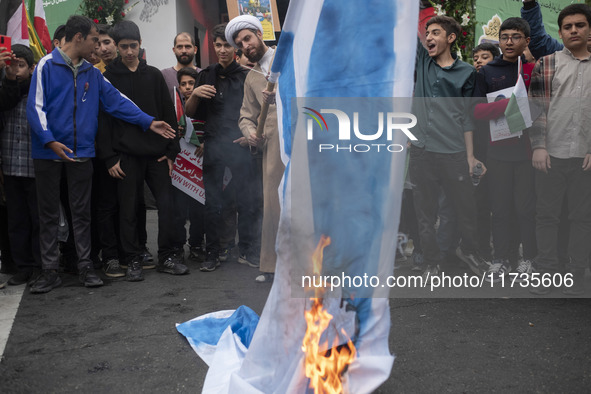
27,15,175,293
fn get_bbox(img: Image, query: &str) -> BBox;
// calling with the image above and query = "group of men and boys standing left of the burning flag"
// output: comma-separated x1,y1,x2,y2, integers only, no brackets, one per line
0,15,284,293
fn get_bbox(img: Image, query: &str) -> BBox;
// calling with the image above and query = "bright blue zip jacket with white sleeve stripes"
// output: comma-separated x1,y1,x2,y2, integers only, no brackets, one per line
27,48,154,160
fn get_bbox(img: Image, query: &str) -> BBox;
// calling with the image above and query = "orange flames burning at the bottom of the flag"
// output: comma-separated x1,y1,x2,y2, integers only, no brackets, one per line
302,235,356,393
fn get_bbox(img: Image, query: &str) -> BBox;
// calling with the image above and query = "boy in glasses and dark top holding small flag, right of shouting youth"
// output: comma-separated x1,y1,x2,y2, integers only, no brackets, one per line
474,18,537,282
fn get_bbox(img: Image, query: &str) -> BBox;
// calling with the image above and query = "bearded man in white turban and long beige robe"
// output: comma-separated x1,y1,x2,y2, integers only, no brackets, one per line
226,15,285,282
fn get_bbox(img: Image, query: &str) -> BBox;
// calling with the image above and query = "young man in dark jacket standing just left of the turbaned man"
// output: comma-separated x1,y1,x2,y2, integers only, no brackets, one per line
186,24,262,272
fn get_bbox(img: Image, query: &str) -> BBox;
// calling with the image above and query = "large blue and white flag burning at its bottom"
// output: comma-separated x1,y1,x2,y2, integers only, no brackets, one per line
177,0,419,393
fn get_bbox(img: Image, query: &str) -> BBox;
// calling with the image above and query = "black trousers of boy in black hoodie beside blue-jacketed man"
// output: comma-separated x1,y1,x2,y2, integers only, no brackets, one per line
117,154,180,261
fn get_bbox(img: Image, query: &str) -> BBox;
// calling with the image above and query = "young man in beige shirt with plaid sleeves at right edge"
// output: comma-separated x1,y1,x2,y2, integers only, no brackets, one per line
529,4,591,295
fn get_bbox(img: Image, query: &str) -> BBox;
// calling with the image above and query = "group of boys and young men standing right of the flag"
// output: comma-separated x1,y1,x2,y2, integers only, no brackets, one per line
401,0,591,295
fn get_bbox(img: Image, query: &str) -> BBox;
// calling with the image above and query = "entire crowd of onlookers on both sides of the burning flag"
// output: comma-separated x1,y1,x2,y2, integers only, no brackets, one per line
0,0,591,295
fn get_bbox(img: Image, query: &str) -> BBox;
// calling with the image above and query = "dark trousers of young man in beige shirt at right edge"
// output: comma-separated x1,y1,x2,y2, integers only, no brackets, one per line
535,157,591,273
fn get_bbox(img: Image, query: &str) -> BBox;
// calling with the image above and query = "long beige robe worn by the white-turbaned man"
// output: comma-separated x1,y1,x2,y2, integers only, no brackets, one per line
239,64,285,272
